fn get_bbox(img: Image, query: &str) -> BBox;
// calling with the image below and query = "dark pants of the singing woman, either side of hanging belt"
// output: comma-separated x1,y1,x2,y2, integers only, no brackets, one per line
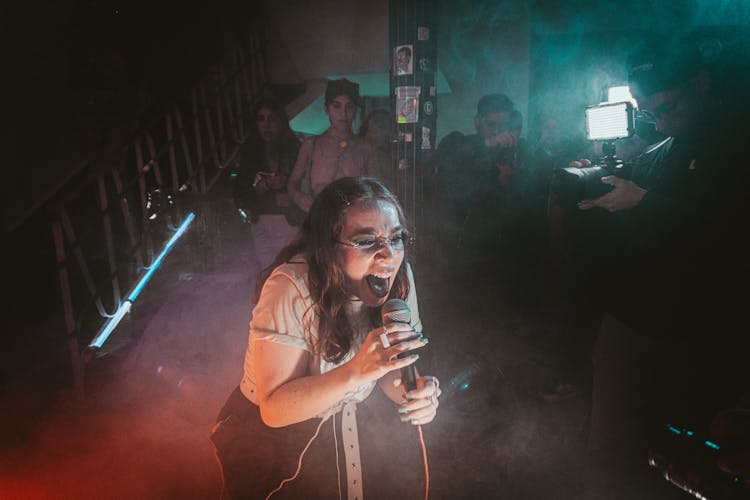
211,388,424,500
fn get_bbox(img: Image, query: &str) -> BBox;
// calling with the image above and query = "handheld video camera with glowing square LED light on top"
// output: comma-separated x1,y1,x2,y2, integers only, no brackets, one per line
555,102,635,204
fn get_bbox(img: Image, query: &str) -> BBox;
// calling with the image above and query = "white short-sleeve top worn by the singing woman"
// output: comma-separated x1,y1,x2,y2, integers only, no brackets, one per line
240,256,422,418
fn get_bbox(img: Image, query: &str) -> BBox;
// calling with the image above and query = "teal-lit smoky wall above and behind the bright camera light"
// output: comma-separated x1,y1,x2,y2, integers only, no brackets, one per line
529,0,750,146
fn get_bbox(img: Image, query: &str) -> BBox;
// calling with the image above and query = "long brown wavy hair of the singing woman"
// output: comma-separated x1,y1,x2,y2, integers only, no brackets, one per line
253,177,409,363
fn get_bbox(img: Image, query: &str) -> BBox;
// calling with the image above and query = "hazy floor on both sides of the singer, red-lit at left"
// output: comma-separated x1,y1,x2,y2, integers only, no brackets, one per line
0,200,692,499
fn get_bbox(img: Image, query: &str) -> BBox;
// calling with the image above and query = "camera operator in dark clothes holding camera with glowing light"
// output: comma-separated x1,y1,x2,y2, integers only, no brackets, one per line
571,37,747,498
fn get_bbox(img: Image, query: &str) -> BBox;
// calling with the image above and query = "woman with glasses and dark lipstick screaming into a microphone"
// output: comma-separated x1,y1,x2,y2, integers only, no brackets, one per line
211,177,440,500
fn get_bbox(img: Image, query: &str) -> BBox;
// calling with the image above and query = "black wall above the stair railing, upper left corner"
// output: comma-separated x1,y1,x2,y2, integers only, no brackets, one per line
1,0,261,230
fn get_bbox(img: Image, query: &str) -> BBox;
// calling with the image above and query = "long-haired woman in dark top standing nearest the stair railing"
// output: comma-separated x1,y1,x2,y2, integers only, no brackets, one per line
234,99,304,269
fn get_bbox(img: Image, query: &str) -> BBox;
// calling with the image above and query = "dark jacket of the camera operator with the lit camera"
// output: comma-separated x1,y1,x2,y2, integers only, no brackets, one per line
598,116,747,336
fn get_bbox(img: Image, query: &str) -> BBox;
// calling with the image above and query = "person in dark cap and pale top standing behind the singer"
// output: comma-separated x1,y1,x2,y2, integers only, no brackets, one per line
287,78,382,212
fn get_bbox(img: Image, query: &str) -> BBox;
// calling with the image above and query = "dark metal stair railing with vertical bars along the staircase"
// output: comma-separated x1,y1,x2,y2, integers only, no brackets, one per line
47,24,268,397
